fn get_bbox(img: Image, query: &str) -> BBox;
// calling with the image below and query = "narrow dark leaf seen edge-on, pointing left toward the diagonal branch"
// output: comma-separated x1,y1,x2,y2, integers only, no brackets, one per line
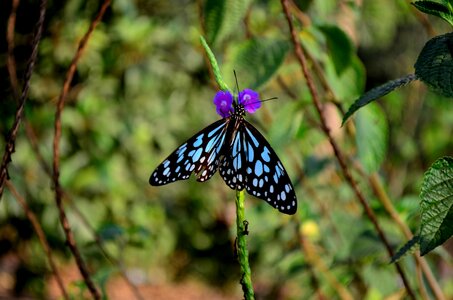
342,74,417,125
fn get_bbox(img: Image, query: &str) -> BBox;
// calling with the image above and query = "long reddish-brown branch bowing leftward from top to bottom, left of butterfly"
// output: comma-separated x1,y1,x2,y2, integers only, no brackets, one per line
53,0,110,299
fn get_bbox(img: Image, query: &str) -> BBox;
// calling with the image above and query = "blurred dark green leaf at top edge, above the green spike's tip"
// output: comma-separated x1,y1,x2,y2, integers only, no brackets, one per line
204,0,225,44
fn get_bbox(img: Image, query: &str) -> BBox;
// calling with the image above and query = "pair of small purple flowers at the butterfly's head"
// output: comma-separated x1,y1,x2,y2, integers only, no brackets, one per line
214,89,261,118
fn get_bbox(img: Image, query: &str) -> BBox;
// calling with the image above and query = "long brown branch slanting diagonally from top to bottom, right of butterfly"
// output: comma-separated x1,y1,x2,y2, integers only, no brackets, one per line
281,0,416,299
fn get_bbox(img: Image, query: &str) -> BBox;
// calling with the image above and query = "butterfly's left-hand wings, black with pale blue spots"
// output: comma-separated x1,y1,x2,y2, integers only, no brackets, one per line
149,118,229,186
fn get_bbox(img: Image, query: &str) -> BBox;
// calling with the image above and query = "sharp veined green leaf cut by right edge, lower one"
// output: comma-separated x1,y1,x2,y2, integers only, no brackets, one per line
420,157,453,255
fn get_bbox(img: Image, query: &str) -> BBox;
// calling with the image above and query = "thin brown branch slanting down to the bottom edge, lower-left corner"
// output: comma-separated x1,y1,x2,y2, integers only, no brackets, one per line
6,180,69,300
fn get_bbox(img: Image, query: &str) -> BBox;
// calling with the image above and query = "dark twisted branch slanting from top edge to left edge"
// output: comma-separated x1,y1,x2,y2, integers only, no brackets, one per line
0,0,47,200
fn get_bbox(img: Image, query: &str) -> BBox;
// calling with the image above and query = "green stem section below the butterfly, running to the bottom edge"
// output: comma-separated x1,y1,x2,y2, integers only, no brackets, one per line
236,190,255,300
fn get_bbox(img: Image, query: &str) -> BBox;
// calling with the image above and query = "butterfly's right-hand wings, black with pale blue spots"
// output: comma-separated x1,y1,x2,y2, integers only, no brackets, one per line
220,119,297,214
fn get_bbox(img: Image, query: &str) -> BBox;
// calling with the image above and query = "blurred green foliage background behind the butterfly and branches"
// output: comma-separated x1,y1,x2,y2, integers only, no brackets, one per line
0,0,453,299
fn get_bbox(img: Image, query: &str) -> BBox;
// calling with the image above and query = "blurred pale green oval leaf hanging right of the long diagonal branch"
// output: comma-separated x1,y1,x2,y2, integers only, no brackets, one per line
356,105,388,173
